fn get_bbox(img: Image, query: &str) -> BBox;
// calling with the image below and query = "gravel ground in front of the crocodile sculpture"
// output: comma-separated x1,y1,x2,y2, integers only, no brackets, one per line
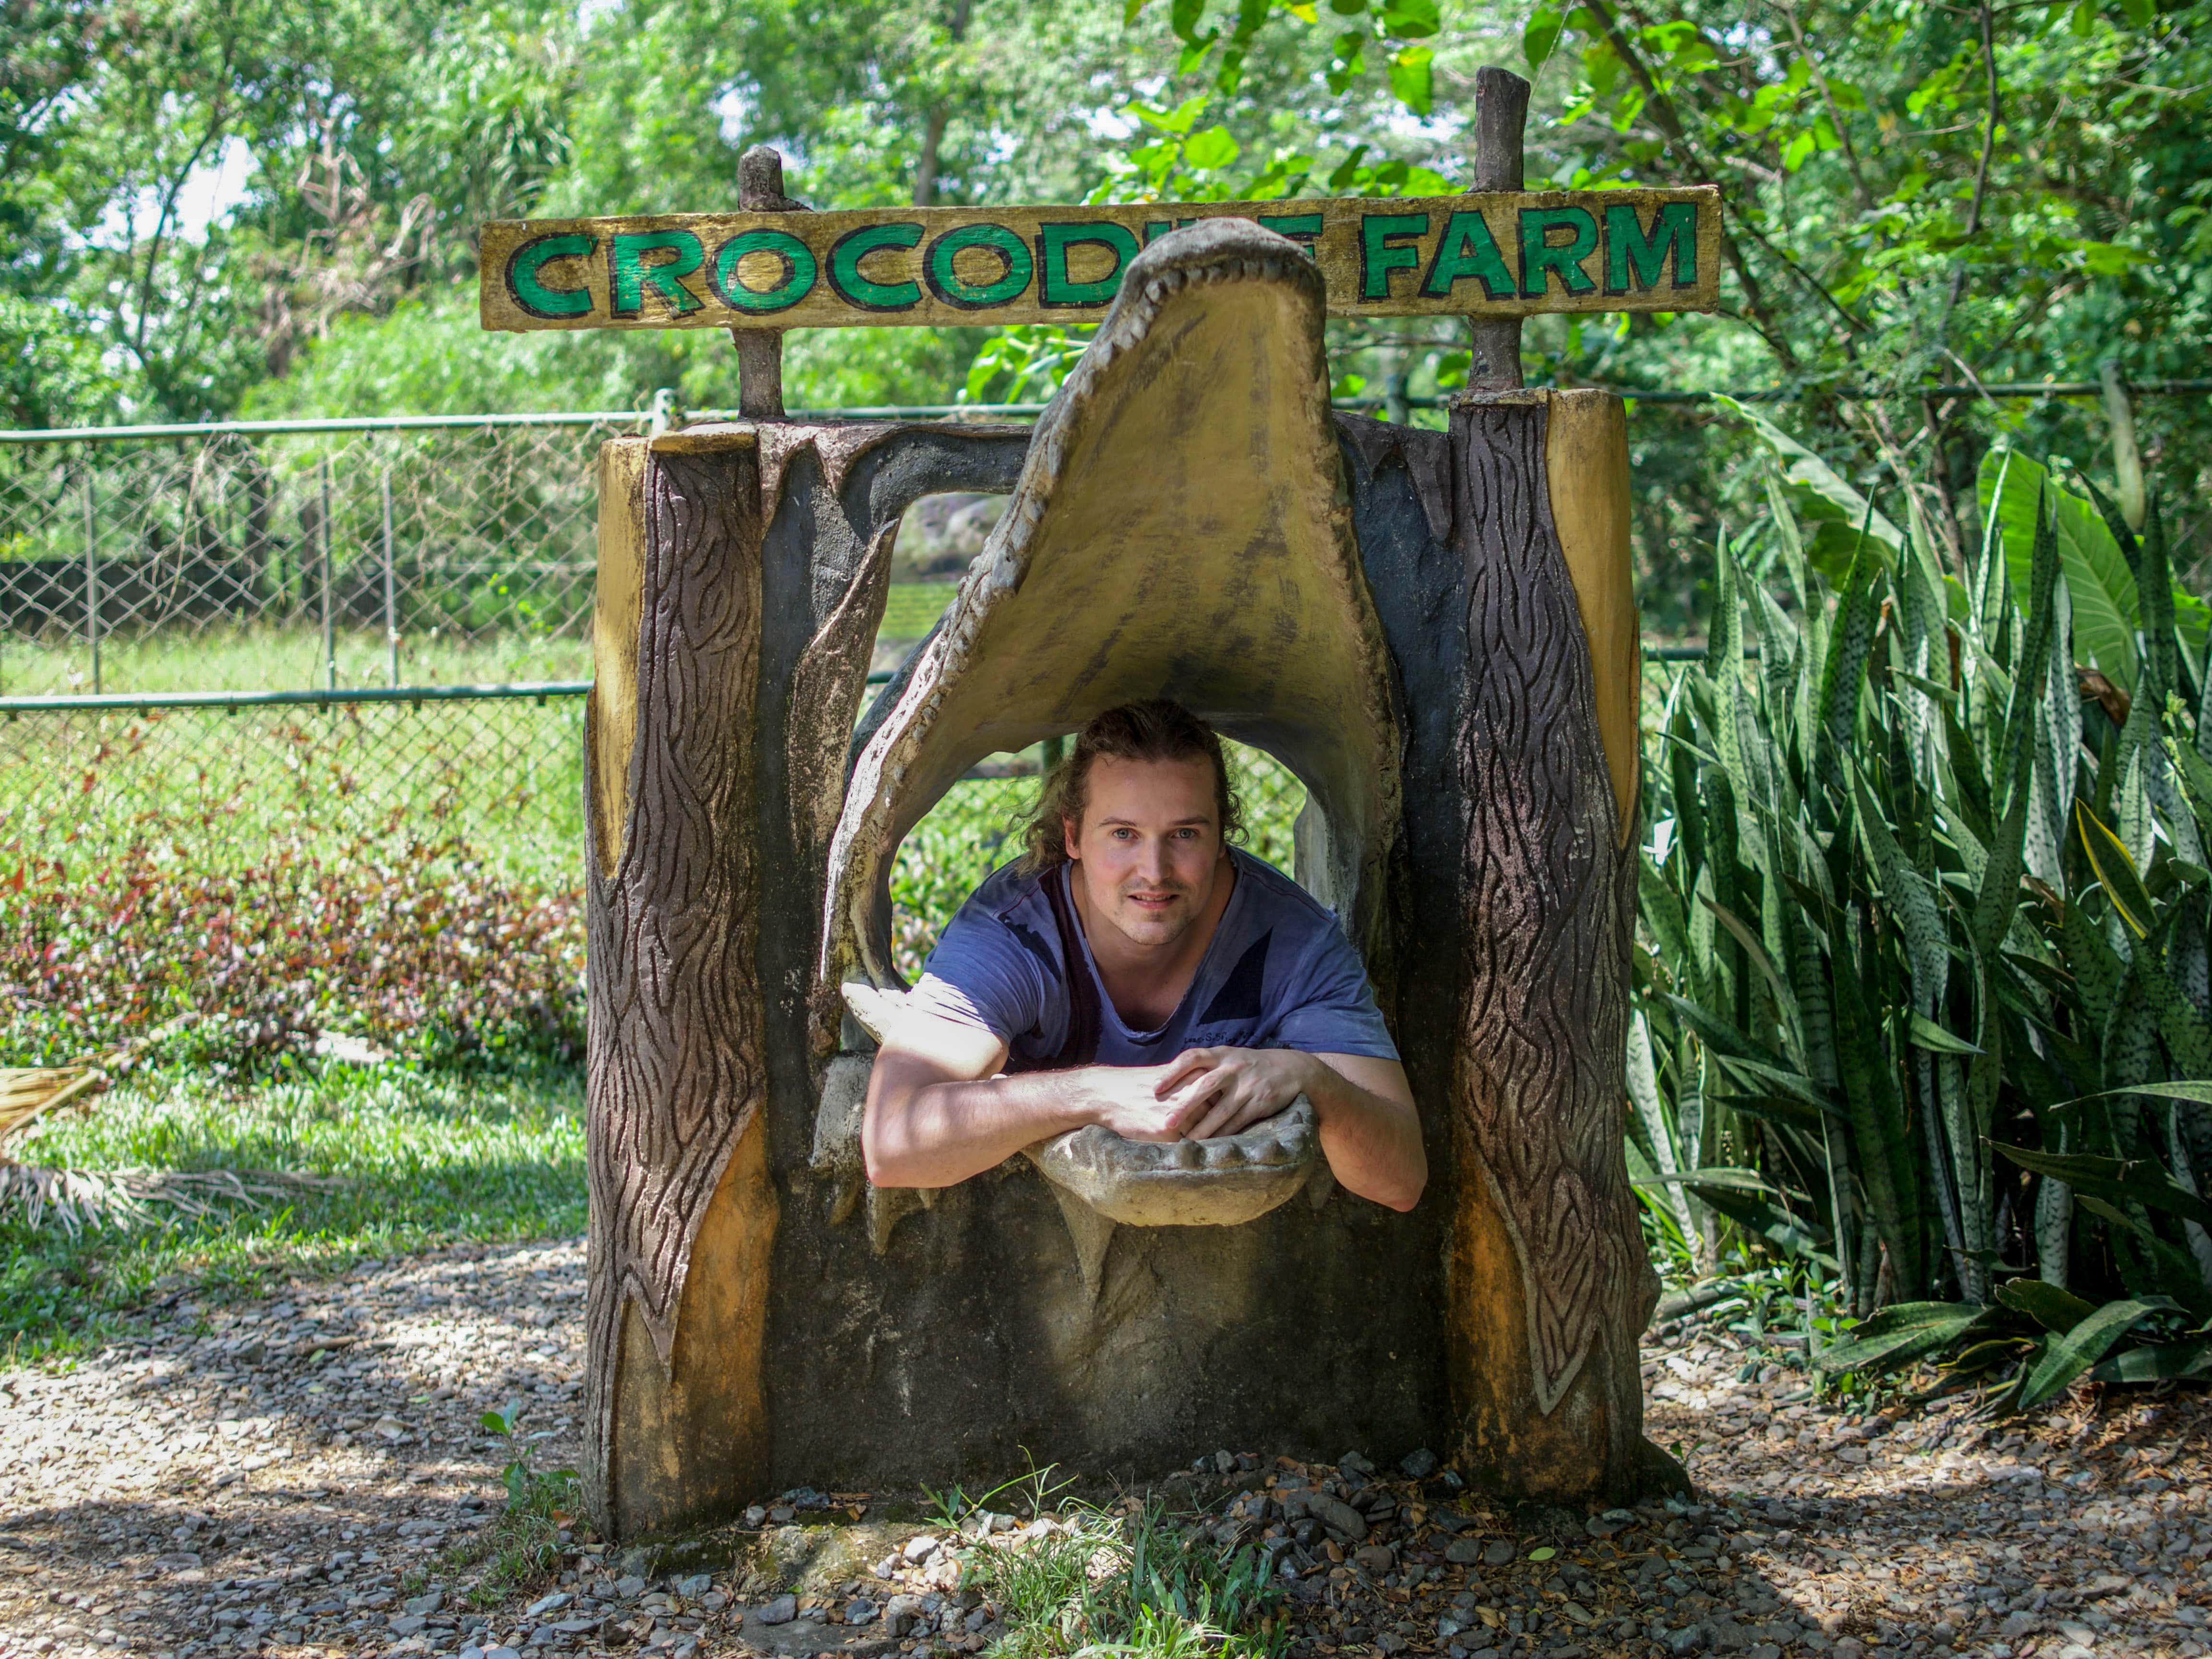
0,1243,2212,1659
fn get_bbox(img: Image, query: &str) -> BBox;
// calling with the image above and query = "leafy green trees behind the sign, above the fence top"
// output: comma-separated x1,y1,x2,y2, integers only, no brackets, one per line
0,0,2212,630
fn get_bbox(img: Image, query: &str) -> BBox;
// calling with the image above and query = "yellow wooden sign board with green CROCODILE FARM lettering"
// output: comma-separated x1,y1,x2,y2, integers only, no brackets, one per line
482,186,1721,332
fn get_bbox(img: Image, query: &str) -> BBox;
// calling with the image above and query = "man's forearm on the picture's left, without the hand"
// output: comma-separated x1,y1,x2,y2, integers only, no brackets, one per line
863,1070,1093,1188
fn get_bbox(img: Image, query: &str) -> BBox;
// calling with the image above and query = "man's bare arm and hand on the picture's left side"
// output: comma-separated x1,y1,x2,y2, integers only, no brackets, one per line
861,1011,1181,1186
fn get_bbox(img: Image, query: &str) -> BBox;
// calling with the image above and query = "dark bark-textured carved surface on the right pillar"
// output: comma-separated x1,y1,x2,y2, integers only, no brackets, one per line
1451,394,1650,1414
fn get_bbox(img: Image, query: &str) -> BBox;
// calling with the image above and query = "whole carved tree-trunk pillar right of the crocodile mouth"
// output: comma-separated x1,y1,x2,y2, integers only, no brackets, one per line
1449,392,1679,1498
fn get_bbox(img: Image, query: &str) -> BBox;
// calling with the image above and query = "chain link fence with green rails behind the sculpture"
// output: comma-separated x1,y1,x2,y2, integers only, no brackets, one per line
0,414,1305,971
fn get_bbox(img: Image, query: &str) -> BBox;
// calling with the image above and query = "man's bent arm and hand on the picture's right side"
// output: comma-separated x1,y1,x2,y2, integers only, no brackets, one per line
1159,1048,1429,1210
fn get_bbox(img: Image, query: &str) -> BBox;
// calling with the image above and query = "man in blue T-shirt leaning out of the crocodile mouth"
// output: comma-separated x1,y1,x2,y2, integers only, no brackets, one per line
861,701,1429,1210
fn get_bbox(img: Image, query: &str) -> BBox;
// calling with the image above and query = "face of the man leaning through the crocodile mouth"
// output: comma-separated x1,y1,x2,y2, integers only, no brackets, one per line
1062,754,1221,945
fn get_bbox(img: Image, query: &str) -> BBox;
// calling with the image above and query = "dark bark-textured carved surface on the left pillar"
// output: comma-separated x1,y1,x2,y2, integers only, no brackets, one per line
586,454,765,1522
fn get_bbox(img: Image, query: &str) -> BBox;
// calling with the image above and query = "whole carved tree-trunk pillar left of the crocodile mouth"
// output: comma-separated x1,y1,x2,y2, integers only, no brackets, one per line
586,438,776,1533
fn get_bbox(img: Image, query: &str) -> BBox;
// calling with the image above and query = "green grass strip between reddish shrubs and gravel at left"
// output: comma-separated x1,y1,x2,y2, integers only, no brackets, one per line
0,1064,584,1363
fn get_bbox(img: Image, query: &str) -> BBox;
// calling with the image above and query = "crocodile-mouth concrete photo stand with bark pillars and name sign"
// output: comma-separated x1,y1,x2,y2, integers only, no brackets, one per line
484,71,1719,1538
